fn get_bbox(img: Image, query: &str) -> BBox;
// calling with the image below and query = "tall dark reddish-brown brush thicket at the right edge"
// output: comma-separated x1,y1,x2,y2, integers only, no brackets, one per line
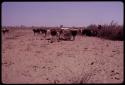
86,21,123,40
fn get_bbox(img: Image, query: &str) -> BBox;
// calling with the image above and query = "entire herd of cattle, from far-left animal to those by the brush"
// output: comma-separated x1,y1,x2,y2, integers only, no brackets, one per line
2,25,101,42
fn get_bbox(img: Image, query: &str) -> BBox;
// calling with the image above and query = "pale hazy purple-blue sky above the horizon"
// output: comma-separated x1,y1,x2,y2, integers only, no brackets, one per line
2,1,124,26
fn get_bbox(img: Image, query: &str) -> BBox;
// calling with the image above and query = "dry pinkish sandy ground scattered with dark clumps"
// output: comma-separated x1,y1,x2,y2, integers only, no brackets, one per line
2,29,124,84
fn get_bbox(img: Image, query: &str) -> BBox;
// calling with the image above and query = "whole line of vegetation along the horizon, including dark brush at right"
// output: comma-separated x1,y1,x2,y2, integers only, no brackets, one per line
2,21,124,41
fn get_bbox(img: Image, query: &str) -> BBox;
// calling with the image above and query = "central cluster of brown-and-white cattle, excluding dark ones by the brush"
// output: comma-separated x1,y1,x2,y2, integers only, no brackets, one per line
33,29,78,41
